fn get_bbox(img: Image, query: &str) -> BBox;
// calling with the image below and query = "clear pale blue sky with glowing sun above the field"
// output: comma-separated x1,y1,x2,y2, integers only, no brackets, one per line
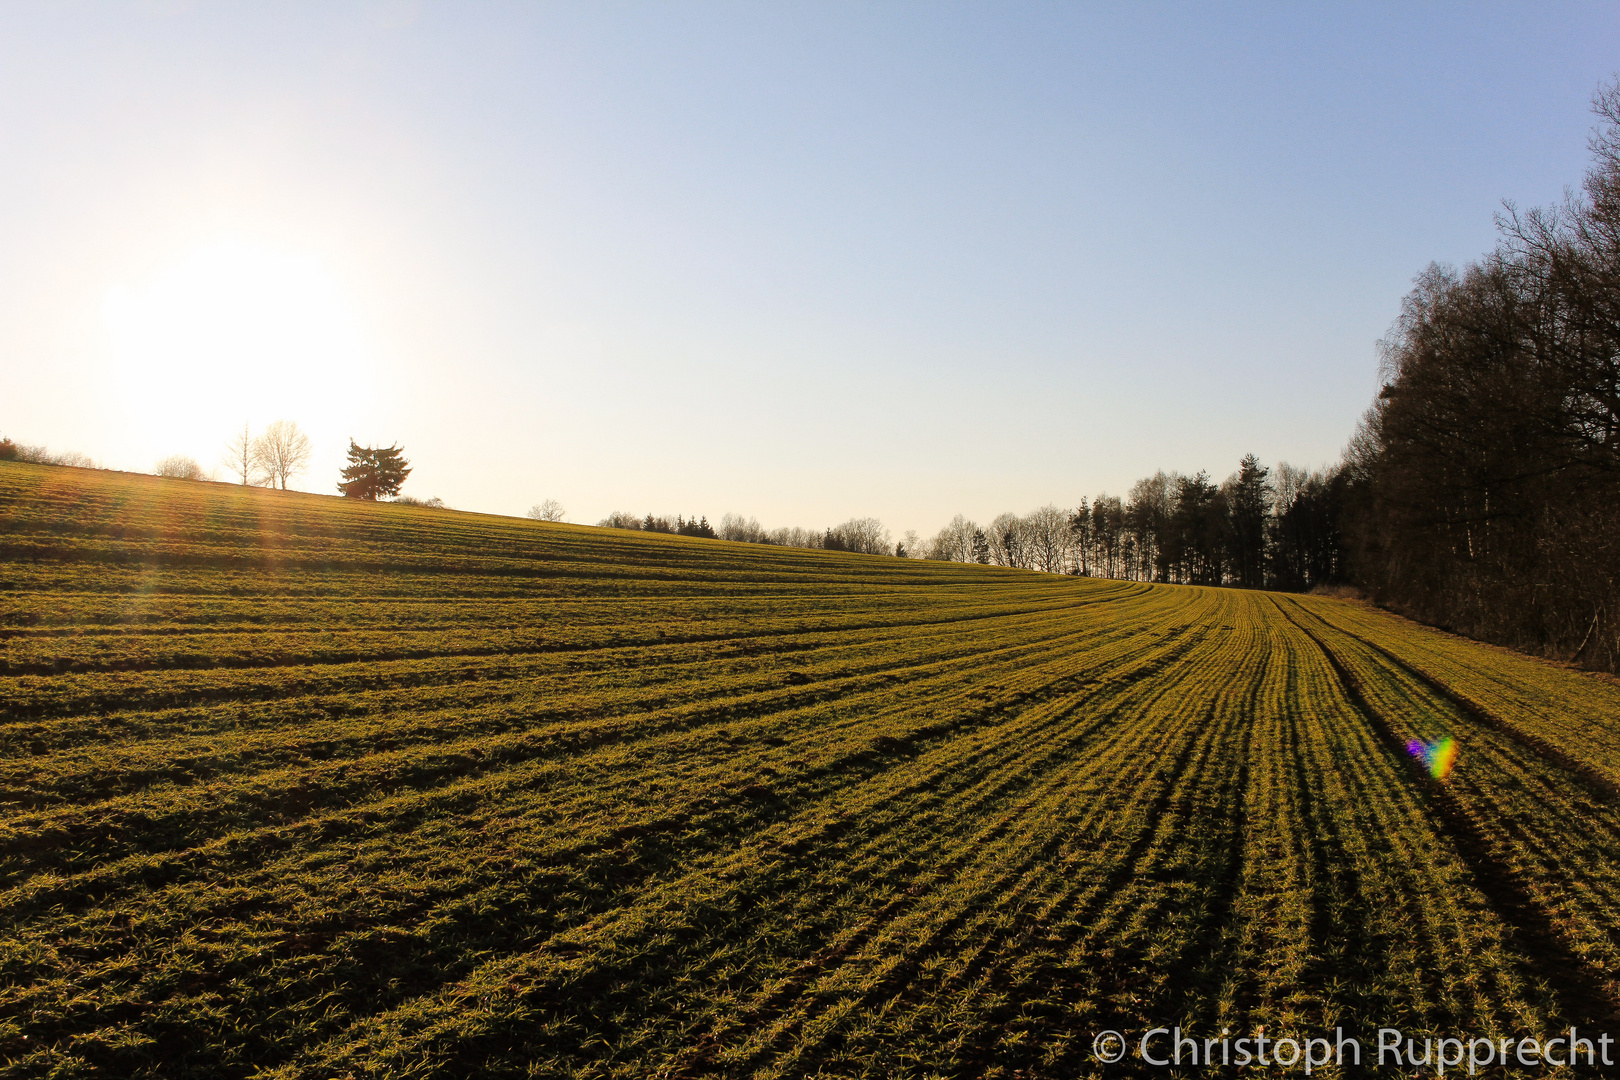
0,3,1620,536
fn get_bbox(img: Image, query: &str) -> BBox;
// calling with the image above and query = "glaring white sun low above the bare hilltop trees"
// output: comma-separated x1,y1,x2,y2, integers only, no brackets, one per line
102,240,376,465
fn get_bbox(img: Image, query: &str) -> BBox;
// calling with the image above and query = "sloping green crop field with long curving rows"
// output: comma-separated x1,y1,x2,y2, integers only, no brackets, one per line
0,463,1620,1078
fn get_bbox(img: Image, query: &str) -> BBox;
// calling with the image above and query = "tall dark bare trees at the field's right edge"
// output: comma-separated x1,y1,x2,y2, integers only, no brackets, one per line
1340,86,1620,672
